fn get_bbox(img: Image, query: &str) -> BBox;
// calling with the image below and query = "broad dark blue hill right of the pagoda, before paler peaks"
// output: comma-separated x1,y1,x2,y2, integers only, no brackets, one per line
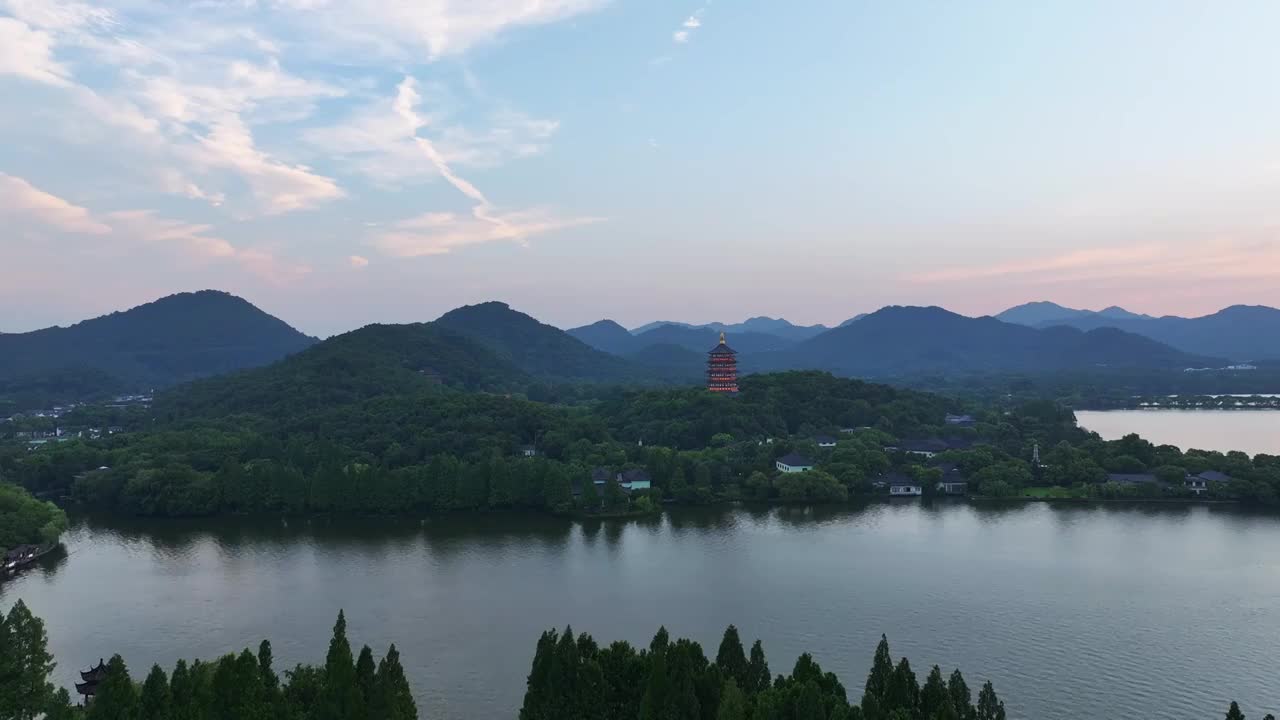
768,307,1222,377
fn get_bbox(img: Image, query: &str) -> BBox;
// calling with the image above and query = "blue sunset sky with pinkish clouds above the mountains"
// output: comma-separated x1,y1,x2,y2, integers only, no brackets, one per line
0,0,1280,336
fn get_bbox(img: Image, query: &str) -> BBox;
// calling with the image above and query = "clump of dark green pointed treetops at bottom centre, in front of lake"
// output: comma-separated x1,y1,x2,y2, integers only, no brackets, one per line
520,625,1005,720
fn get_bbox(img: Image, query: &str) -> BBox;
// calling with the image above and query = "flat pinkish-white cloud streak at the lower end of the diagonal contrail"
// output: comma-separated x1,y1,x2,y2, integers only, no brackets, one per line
370,206,600,258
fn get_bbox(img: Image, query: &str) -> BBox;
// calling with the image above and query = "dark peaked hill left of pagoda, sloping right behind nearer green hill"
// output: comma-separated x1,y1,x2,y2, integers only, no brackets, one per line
435,302,646,382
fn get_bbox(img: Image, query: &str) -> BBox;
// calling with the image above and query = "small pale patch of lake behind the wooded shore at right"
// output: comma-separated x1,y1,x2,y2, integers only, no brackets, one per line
1075,410,1280,455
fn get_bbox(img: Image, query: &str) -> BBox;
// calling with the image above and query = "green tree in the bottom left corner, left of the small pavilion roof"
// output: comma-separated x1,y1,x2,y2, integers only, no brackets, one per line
0,600,54,720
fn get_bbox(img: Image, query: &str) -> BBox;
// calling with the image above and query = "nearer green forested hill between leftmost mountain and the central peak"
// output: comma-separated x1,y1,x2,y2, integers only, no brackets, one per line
156,323,531,419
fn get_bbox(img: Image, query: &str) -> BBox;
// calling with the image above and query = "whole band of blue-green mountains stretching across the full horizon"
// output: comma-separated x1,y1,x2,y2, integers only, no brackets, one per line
10,291,1280,410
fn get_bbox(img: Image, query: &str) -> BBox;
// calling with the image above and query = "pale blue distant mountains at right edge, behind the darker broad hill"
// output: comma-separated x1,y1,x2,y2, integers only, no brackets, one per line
996,302,1280,363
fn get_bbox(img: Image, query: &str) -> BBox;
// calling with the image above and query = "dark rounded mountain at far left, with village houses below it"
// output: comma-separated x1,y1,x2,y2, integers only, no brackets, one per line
0,290,316,389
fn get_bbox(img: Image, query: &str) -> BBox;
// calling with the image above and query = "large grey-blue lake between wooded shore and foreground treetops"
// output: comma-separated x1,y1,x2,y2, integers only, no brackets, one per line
0,502,1280,720
